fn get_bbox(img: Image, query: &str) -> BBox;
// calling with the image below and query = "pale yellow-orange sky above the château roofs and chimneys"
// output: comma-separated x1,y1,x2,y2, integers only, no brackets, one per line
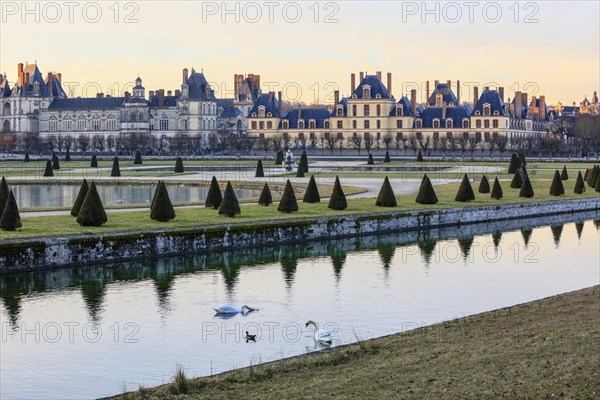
0,0,600,104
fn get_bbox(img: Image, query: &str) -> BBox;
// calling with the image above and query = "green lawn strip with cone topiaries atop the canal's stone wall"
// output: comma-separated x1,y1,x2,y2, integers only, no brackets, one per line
0,179,600,241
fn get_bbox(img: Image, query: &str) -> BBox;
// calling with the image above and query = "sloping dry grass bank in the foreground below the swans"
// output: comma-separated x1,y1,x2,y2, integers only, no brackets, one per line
115,286,600,400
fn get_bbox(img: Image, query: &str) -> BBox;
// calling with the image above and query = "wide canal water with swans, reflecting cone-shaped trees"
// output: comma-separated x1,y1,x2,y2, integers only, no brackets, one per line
0,212,600,399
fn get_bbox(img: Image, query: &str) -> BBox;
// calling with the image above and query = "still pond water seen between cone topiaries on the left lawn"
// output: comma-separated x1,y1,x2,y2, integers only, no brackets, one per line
11,183,260,208
